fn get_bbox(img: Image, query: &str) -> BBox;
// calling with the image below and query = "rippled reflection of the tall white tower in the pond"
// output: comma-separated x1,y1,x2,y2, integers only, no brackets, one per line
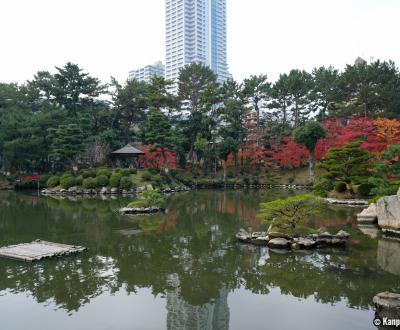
167,274,229,330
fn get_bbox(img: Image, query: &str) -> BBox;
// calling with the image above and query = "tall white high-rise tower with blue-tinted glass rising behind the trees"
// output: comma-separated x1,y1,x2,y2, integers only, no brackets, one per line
165,0,231,89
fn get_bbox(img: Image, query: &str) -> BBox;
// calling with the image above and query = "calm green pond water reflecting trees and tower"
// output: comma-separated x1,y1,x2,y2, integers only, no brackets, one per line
0,190,400,330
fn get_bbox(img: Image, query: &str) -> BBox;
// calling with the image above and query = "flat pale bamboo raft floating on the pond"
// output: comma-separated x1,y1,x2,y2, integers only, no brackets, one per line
0,240,86,262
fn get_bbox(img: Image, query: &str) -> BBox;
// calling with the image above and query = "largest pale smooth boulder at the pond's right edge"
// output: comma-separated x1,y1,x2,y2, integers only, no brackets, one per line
376,194,400,234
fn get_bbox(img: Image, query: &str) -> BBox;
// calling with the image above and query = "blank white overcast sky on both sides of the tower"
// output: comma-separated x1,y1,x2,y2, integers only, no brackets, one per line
0,0,400,82
